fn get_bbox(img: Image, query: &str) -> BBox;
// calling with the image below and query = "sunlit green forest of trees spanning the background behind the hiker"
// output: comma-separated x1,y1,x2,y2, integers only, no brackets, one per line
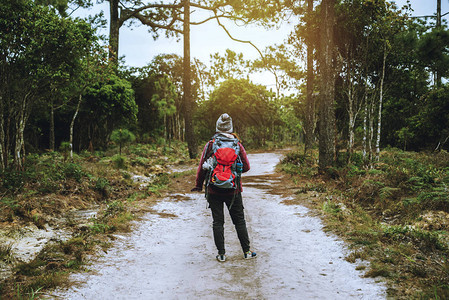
0,1,449,170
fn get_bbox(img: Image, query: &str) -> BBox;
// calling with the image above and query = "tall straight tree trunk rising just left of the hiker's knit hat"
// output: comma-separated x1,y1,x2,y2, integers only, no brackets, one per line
182,0,197,158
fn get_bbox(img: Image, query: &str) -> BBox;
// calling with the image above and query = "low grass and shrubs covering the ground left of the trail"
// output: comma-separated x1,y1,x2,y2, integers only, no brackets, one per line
0,143,190,299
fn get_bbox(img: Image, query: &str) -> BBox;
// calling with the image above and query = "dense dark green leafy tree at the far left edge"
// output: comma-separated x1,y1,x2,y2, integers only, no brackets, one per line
0,0,97,168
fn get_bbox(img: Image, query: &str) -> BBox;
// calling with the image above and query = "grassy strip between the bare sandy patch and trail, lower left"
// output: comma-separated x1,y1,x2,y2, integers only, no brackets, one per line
2,209,133,299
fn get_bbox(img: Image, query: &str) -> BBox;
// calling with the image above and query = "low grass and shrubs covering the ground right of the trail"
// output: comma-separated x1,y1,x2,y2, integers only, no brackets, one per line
280,149,449,299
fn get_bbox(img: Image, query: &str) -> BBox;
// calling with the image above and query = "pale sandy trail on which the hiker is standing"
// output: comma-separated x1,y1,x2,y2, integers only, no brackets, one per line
47,153,386,299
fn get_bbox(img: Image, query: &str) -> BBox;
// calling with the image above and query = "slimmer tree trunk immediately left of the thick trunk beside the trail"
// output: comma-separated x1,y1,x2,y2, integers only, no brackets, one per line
304,0,315,154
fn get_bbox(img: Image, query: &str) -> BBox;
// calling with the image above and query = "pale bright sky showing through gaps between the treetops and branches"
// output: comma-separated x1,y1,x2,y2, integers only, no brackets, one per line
76,0,449,88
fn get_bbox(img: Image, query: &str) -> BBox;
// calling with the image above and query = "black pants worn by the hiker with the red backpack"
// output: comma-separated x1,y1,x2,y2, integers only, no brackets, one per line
208,193,249,254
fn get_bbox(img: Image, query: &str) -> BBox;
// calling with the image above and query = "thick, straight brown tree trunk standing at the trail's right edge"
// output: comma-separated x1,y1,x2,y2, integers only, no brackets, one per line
318,0,335,170
